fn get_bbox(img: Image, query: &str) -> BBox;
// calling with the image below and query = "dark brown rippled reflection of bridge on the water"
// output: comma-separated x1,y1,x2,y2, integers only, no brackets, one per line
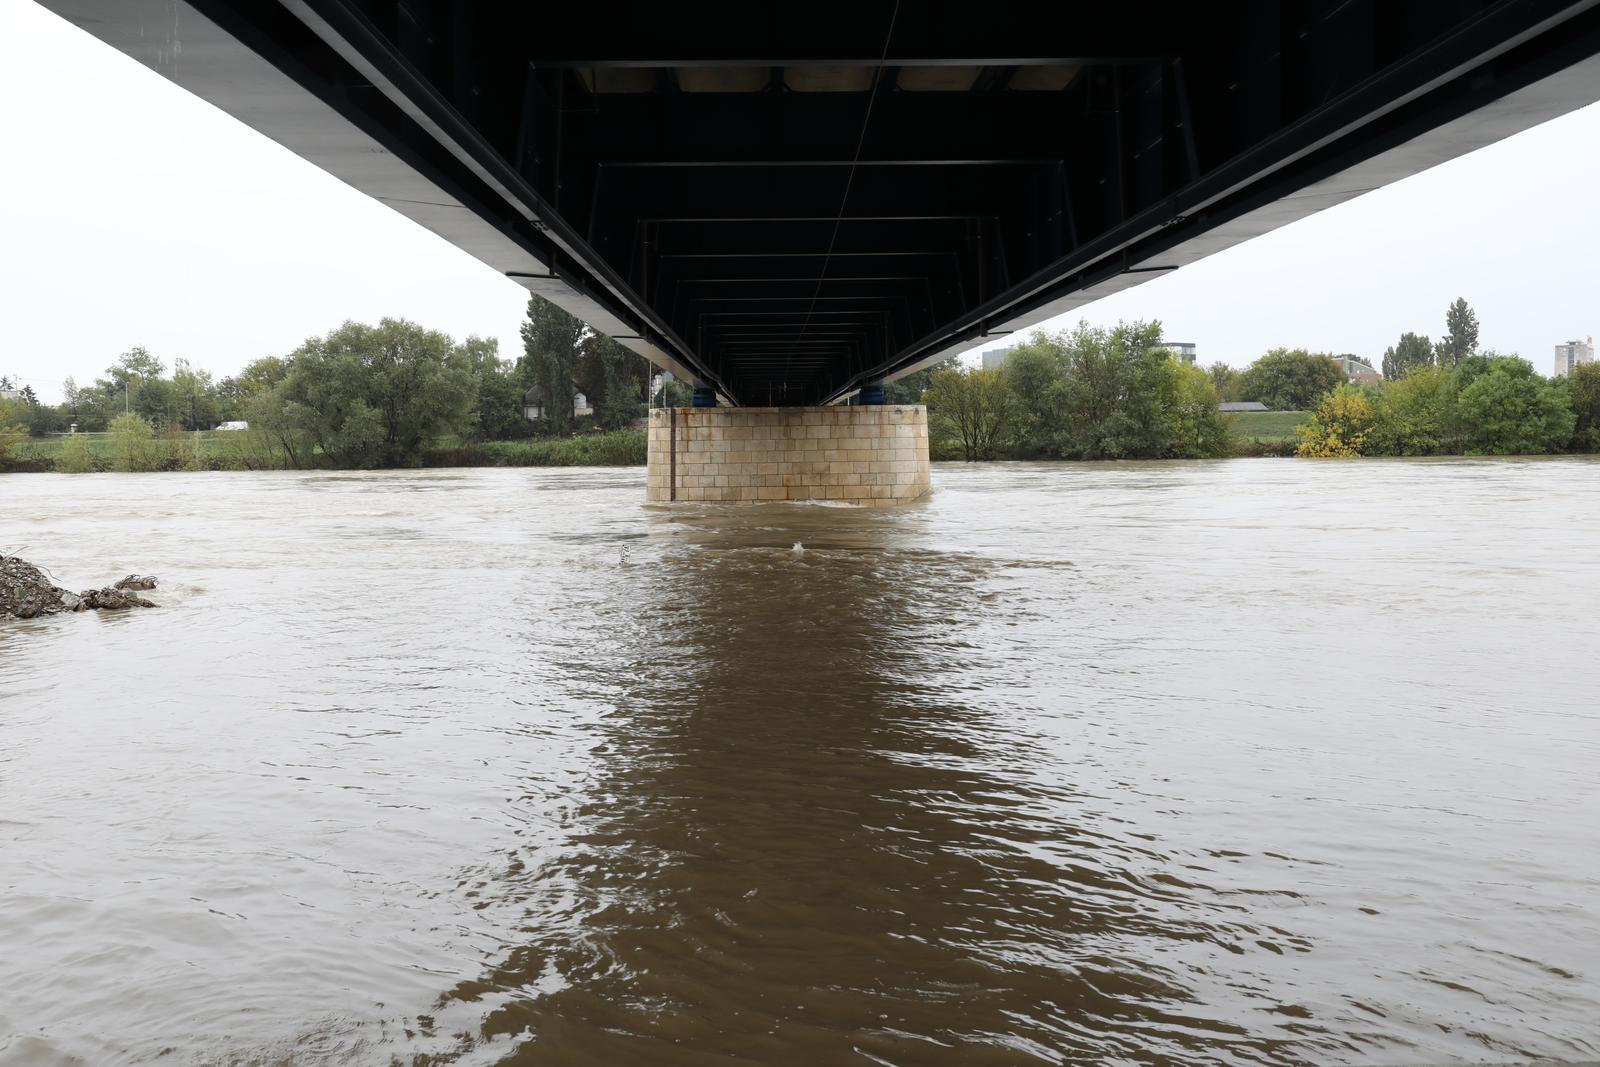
437,507,1320,1067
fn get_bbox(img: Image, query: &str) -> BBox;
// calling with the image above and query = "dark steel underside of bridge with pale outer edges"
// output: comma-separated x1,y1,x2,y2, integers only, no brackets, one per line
46,0,1600,405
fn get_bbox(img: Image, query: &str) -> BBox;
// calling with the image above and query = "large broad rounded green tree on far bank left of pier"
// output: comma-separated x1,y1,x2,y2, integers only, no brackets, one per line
268,318,477,467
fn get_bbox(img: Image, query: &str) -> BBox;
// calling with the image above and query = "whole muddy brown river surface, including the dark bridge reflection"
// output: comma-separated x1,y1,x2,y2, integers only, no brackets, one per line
0,459,1600,1067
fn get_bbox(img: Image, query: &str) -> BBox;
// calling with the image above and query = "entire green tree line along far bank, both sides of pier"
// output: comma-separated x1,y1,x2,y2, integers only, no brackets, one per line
0,296,1600,472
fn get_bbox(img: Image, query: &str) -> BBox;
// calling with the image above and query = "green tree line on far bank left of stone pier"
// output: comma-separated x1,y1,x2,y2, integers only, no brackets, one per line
0,296,675,472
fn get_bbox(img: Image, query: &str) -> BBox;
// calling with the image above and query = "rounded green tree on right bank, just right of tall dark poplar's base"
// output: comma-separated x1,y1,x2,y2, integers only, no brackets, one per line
1456,358,1576,456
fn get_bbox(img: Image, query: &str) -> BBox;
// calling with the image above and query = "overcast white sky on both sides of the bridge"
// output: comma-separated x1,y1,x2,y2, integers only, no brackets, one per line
0,0,1600,400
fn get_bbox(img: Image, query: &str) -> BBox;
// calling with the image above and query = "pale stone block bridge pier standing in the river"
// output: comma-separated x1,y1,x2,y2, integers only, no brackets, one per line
646,405,928,506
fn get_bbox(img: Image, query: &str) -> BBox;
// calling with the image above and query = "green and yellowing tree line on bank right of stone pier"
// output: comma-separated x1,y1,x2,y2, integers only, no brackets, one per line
893,299,1600,459
